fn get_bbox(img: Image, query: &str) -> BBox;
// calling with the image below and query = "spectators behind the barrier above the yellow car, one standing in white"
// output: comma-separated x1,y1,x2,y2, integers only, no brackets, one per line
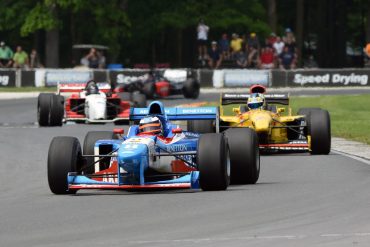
197,20,317,69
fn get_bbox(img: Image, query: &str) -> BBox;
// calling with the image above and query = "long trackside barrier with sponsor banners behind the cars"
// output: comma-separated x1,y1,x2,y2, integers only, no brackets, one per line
0,68,370,87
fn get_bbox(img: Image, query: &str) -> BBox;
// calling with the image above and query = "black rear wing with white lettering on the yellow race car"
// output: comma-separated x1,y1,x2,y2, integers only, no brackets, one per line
221,93,289,105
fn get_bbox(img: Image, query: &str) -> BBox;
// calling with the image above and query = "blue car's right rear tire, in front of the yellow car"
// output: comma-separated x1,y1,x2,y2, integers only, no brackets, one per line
224,128,260,184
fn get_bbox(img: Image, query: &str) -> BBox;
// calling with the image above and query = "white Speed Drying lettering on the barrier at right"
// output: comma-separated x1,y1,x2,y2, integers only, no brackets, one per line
293,73,369,86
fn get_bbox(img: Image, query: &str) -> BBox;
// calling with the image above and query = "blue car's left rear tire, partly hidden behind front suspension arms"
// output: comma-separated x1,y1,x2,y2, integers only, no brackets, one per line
83,131,117,174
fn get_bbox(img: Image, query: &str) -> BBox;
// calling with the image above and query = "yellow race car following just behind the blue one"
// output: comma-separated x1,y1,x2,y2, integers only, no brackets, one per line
189,85,331,154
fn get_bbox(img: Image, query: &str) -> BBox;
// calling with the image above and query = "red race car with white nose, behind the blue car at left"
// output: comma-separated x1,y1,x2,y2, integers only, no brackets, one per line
37,81,146,126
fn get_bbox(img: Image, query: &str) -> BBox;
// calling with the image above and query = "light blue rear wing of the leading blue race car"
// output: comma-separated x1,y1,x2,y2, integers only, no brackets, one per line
130,107,219,121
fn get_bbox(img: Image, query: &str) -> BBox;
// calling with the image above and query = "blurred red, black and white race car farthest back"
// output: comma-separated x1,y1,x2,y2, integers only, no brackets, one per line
115,69,200,99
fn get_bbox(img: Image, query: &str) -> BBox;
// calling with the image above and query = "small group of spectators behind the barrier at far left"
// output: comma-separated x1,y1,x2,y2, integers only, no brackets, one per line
0,41,43,69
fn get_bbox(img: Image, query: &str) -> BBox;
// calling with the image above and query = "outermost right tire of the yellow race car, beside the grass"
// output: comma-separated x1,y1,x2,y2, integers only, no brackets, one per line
307,109,331,154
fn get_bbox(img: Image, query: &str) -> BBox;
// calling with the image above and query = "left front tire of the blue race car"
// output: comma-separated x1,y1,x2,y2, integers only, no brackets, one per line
48,136,83,195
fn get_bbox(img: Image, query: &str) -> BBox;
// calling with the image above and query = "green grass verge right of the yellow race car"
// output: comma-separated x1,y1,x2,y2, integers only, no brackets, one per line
205,94,370,144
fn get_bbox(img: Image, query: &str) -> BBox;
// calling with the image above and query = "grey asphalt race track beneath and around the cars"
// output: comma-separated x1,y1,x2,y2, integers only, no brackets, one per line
0,93,370,247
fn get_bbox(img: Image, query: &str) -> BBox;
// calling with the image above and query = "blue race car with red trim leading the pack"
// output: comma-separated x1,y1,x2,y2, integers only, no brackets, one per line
48,101,260,194
